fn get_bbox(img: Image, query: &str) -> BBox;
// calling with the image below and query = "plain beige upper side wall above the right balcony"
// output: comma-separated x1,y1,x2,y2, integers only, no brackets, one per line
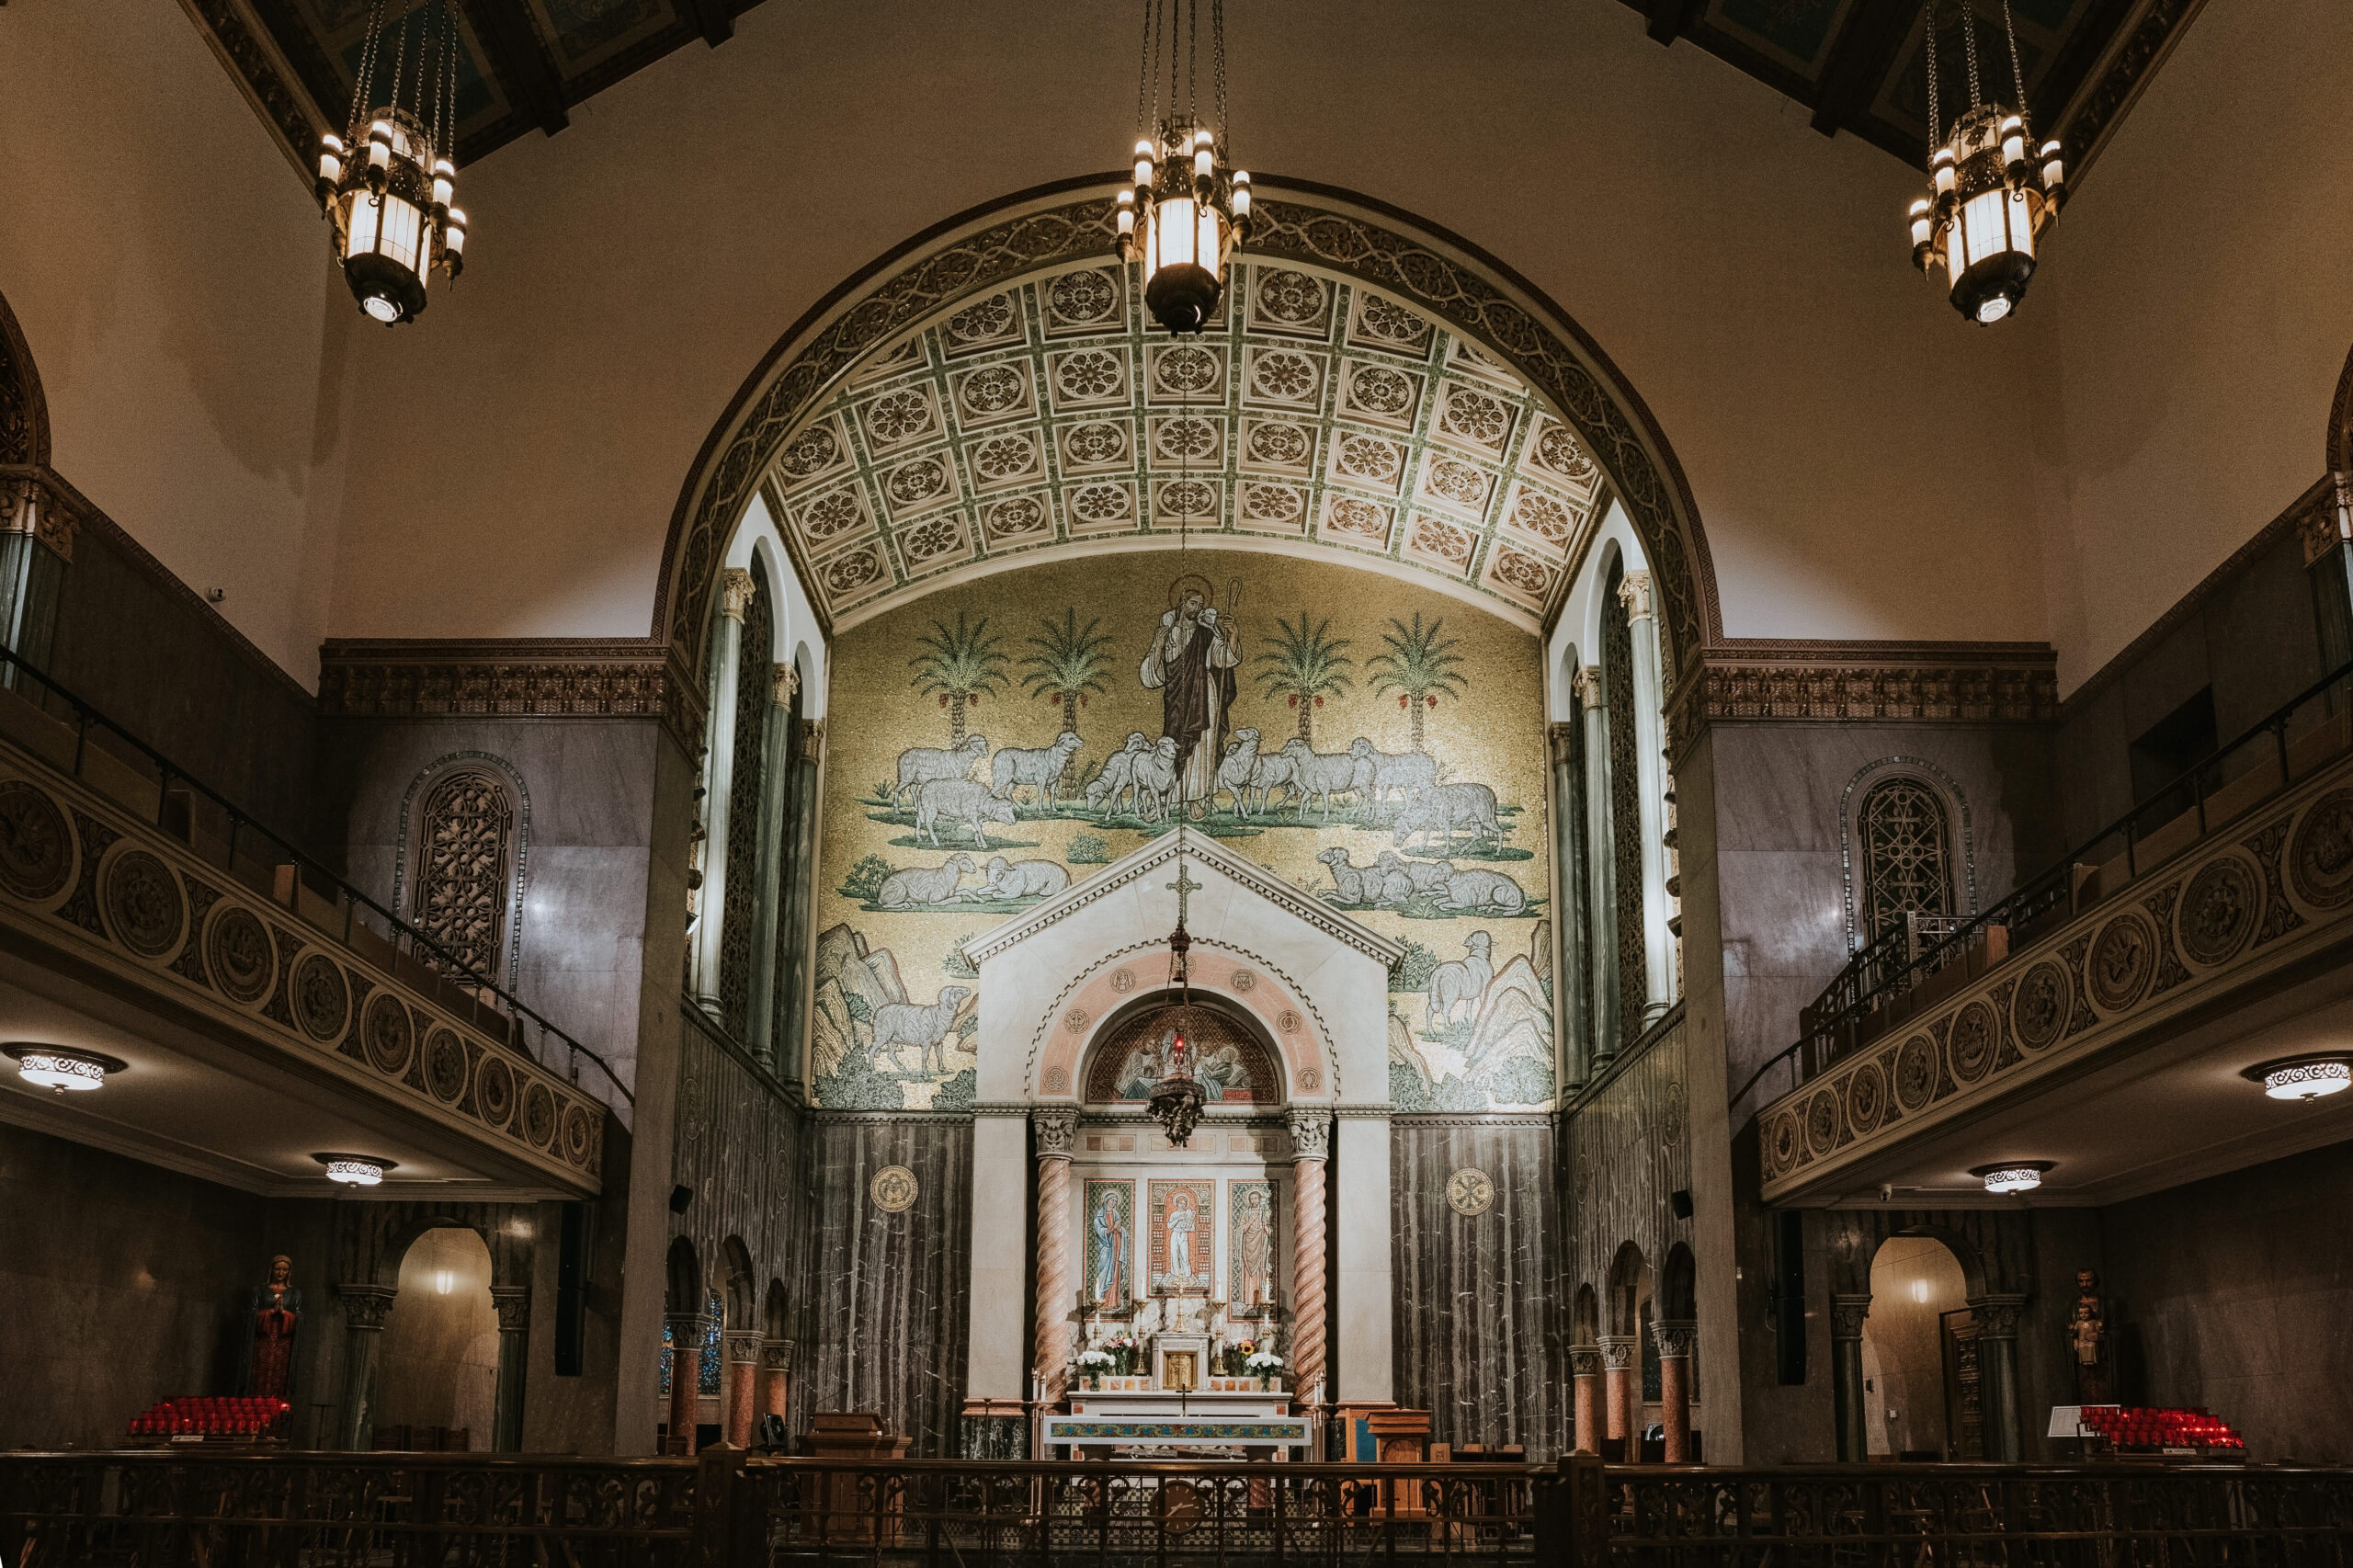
2026,0,2353,692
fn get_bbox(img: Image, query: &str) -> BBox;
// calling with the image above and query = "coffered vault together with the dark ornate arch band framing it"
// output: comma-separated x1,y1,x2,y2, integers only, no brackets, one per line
656,179,1720,662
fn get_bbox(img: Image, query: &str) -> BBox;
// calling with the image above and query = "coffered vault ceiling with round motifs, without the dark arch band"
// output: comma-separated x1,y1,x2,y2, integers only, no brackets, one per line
762,252,1602,629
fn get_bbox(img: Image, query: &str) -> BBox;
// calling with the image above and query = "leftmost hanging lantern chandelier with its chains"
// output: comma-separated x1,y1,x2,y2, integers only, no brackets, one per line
318,0,466,327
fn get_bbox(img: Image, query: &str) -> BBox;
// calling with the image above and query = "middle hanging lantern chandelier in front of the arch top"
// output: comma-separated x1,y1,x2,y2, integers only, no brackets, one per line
1118,0,1249,332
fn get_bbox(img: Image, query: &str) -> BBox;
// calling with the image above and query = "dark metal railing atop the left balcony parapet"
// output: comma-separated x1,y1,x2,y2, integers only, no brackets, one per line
0,647,635,1102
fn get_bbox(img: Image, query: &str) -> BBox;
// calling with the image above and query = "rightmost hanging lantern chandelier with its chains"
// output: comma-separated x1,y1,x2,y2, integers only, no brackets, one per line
1911,0,2066,327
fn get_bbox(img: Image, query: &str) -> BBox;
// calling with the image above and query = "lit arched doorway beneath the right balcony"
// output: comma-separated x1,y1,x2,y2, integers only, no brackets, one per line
1864,1236,1984,1460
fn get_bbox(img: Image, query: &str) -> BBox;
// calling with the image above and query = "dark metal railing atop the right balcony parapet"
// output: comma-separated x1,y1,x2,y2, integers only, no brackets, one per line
1732,664,2353,1111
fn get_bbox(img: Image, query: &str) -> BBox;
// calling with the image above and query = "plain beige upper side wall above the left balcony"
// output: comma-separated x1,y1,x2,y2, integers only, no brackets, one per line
0,0,353,683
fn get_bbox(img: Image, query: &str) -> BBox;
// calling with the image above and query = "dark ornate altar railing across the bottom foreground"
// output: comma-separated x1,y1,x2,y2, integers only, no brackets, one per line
0,1450,2353,1568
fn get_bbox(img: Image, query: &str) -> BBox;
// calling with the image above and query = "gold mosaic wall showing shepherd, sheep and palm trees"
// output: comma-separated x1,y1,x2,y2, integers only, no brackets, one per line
810,551,1555,1111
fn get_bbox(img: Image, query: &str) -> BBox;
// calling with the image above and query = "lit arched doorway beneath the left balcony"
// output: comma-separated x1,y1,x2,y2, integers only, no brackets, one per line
374,1224,499,1450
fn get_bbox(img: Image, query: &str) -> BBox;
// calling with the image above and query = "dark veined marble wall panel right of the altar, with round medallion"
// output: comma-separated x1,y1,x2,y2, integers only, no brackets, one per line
1388,1116,1570,1460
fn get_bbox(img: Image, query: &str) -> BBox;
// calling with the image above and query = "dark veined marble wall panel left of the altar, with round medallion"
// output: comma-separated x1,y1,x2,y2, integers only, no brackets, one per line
790,1116,964,1458
